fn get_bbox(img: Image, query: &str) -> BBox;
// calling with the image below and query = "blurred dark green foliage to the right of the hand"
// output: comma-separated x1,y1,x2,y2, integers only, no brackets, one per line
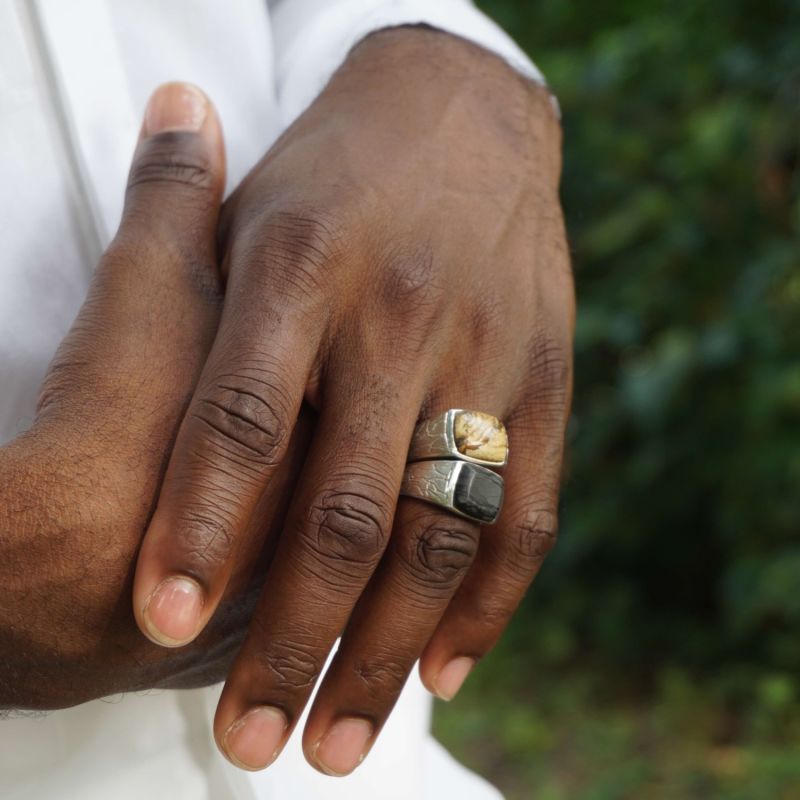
442,0,800,799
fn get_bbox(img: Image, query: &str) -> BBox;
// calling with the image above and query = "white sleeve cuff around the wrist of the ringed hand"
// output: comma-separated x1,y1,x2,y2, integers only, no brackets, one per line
269,0,544,125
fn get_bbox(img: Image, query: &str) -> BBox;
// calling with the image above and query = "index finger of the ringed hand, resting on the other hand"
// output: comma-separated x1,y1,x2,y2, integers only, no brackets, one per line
133,219,325,647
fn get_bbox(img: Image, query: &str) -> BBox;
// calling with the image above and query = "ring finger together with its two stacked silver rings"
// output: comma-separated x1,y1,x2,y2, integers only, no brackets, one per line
303,412,507,775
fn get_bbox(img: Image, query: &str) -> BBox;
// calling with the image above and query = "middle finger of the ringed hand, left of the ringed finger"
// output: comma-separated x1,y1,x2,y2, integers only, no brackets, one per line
209,345,425,768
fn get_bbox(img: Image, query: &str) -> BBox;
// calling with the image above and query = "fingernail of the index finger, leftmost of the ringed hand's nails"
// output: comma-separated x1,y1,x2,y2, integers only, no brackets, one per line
142,577,203,647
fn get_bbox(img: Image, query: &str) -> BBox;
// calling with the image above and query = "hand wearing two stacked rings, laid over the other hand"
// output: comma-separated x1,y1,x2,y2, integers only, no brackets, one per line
134,29,574,774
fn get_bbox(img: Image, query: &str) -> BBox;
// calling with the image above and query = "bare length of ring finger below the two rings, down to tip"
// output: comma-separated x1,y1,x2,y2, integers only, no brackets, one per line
303,498,479,774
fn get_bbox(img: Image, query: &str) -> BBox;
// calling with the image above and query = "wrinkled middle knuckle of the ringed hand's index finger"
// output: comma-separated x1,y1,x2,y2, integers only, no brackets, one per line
192,379,289,466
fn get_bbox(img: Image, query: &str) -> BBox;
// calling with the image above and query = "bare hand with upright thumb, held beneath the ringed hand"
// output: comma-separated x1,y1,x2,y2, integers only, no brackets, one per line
0,85,307,708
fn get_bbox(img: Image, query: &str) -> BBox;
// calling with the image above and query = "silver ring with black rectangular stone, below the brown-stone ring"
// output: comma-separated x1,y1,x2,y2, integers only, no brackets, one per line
400,461,504,525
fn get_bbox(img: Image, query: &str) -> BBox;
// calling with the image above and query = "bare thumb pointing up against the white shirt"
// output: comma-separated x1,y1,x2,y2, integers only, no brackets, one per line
39,84,225,444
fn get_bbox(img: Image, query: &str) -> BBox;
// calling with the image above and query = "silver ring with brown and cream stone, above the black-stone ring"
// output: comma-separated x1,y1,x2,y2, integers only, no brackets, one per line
408,408,508,468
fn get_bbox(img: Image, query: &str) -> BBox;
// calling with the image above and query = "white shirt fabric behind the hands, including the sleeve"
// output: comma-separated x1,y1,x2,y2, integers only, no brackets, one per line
0,0,539,800
